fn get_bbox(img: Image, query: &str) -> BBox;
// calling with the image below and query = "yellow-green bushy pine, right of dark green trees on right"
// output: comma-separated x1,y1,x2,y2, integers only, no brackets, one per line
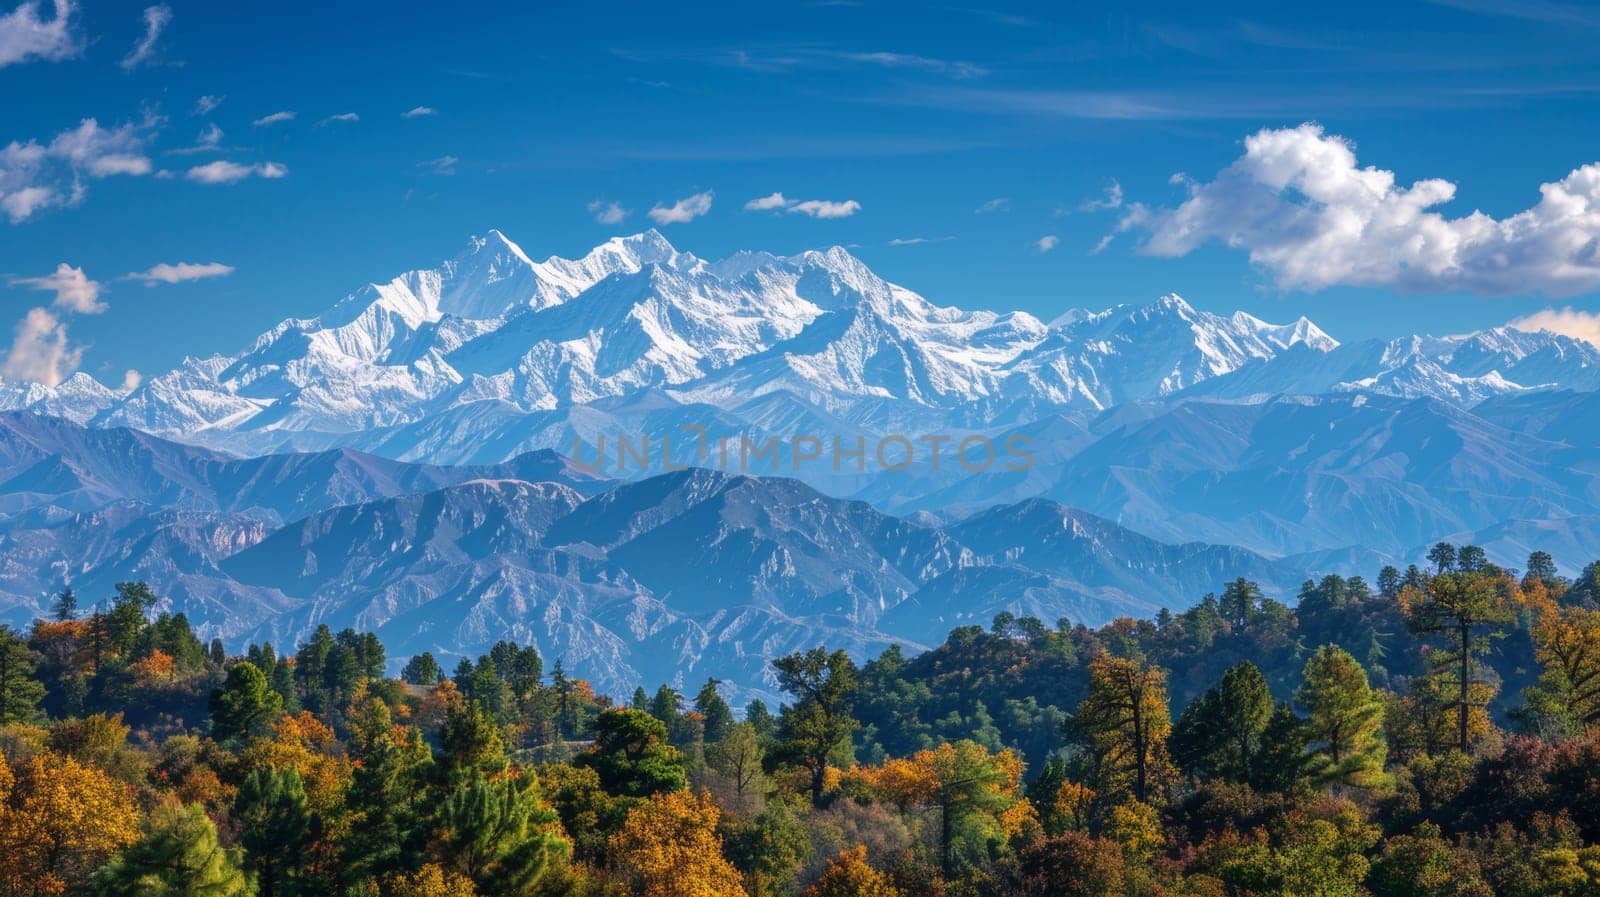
1294,644,1387,787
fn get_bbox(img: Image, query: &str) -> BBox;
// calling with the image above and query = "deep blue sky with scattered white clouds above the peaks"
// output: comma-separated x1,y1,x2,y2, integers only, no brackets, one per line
0,0,1600,385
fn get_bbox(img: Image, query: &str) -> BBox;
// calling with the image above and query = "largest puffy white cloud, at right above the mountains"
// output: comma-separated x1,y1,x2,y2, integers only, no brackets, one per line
1118,125,1600,296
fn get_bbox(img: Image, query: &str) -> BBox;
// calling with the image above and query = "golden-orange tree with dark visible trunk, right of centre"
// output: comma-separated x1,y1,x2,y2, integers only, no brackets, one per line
1075,654,1173,801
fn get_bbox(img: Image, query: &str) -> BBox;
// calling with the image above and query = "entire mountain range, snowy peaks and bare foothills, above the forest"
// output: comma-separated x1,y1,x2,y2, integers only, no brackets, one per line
0,230,1600,691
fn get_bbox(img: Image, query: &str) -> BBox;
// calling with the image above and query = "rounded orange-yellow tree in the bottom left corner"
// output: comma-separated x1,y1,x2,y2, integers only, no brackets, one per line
0,753,139,897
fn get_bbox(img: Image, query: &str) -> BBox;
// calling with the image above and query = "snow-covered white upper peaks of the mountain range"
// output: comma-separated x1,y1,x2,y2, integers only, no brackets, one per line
0,230,1600,462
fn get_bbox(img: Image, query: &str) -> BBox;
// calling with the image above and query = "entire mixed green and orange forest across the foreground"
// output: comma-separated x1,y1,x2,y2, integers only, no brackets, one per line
0,542,1600,897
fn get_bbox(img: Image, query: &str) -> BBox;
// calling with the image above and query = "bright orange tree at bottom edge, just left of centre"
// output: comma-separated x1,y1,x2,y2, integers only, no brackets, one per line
611,791,744,897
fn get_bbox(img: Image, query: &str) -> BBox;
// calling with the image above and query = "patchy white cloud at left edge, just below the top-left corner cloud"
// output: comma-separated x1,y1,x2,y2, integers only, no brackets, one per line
0,118,152,224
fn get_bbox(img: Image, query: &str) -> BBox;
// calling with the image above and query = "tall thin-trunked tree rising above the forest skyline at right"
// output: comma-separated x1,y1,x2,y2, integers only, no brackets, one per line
1400,571,1512,753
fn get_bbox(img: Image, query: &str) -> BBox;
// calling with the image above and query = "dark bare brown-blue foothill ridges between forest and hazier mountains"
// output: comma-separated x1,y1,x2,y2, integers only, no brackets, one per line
0,419,1307,696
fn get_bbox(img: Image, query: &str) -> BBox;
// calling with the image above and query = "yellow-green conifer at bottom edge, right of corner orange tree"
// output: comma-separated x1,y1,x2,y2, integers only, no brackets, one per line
93,804,254,897
